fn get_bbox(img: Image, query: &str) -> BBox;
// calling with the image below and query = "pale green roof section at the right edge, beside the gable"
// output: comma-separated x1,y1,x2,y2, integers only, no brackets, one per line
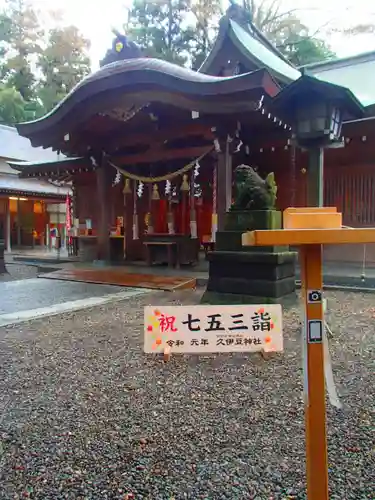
304,51,375,106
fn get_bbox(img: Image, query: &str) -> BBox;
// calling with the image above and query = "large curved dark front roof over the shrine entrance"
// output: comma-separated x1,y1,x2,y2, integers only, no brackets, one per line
17,58,280,148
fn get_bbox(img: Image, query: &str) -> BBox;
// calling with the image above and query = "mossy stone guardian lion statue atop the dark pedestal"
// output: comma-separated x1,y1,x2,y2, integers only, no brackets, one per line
230,165,277,211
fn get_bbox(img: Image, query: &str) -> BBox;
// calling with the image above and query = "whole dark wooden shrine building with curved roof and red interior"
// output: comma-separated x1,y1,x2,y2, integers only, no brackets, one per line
8,5,375,264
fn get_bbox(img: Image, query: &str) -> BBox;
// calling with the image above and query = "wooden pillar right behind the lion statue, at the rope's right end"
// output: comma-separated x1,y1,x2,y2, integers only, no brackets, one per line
217,141,232,231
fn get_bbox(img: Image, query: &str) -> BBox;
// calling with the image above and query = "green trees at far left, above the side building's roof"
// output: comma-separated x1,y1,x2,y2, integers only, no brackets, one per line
0,0,90,124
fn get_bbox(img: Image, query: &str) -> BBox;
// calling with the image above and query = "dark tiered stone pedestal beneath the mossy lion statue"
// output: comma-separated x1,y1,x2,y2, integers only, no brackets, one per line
202,211,296,304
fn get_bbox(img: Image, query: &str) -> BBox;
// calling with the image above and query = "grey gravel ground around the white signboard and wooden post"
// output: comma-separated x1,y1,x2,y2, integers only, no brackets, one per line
0,292,375,500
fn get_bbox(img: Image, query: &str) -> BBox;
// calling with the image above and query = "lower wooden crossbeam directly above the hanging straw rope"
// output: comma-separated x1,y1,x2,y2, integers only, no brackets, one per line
111,145,212,167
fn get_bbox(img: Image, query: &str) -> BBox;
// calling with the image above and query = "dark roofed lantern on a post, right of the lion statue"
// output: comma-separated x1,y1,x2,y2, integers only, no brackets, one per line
273,75,364,207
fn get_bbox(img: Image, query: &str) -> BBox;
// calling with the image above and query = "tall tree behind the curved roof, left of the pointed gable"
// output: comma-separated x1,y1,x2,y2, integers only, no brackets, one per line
126,0,194,65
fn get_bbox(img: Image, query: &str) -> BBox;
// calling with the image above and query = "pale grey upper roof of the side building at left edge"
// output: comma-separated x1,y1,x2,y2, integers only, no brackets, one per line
0,125,63,161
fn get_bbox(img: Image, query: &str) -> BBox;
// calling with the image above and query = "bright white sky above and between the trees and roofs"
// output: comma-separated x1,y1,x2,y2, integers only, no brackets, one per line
0,0,375,66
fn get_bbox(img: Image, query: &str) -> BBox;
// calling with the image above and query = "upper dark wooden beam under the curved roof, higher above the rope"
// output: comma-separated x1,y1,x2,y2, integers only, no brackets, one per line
104,122,213,152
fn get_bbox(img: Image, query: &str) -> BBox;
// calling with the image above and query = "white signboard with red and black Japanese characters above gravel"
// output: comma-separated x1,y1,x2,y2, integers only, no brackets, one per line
144,304,283,354
